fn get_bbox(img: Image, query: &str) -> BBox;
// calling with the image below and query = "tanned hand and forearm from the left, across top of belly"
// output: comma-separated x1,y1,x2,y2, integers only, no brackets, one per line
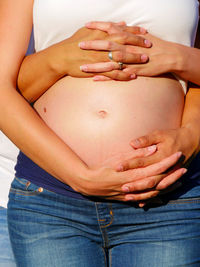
18,23,151,102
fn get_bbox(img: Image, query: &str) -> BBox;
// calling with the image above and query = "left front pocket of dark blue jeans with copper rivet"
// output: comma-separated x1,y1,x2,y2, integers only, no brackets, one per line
9,177,43,196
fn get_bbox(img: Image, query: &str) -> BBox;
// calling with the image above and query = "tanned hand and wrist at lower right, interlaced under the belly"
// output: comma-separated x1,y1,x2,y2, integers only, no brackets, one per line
118,88,200,206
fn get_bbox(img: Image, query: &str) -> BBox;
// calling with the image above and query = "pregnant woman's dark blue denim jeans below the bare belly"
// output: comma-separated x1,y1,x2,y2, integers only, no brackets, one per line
8,178,200,267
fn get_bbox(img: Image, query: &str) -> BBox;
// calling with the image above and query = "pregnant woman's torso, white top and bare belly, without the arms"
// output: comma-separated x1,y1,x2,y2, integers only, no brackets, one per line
34,0,198,169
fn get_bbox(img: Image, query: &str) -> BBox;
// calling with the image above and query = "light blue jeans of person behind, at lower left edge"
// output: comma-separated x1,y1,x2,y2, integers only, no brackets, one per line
0,207,16,267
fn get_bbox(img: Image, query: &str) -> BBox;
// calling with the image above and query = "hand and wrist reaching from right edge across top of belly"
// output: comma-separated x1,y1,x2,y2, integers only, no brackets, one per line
81,22,200,85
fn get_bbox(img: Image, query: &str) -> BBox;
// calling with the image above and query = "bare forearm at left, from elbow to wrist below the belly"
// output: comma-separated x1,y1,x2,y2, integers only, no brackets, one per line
0,83,87,186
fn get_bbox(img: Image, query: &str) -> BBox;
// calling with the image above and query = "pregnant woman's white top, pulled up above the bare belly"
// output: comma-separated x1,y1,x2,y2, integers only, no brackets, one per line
33,0,199,51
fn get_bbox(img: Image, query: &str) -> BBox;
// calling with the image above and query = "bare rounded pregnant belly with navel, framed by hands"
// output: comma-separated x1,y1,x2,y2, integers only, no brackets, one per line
34,76,184,167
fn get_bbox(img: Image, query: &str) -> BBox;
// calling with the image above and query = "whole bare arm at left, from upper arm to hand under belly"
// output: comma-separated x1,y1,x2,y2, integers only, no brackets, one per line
0,0,186,201
